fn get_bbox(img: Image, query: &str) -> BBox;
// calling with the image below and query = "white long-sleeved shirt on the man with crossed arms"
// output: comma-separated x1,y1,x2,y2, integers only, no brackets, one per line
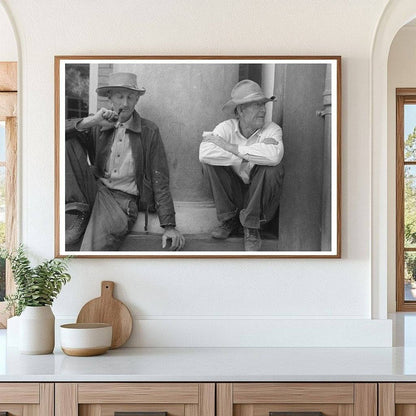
199,119,284,183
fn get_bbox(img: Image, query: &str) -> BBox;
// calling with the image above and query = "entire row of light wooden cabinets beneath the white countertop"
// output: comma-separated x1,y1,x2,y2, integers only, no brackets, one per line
0,383,384,416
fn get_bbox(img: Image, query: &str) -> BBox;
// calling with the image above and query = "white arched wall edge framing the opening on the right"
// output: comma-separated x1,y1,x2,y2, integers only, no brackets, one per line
370,0,416,319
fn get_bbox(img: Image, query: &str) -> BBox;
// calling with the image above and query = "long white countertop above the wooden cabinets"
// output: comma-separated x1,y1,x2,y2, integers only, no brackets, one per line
0,331,416,382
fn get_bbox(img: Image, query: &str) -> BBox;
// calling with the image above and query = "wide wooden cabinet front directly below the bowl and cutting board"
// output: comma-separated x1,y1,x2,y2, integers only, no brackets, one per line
55,383,215,416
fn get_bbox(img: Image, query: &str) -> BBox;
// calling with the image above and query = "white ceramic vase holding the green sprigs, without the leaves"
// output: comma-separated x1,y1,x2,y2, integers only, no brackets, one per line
19,306,55,354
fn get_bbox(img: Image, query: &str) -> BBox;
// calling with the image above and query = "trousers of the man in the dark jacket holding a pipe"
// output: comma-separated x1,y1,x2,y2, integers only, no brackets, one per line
65,138,138,251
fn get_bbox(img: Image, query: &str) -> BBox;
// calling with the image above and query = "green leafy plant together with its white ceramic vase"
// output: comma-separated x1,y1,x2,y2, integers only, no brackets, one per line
0,245,71,354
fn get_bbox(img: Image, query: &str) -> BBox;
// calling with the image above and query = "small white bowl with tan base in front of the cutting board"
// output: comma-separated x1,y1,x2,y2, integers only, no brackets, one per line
60,323,113,357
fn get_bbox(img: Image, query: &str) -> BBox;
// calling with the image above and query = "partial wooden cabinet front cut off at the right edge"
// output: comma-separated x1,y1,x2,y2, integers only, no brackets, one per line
379,383,416,416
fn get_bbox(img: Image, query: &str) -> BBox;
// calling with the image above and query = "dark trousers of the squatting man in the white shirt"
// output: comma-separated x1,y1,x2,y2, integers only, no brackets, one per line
203,164,284,229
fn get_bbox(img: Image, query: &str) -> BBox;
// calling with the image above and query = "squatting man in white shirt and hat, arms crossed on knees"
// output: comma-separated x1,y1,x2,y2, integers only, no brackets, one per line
199,79,284,251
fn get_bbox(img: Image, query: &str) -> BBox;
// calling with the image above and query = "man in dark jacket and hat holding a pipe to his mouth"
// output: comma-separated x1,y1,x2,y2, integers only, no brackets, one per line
65,72,185,251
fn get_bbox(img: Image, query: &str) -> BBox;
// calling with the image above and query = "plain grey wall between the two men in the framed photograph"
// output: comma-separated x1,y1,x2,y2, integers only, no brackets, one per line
114,64,238,202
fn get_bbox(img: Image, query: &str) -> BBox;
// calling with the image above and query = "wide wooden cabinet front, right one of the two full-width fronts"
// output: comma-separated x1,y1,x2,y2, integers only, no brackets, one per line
217,383,377,416
